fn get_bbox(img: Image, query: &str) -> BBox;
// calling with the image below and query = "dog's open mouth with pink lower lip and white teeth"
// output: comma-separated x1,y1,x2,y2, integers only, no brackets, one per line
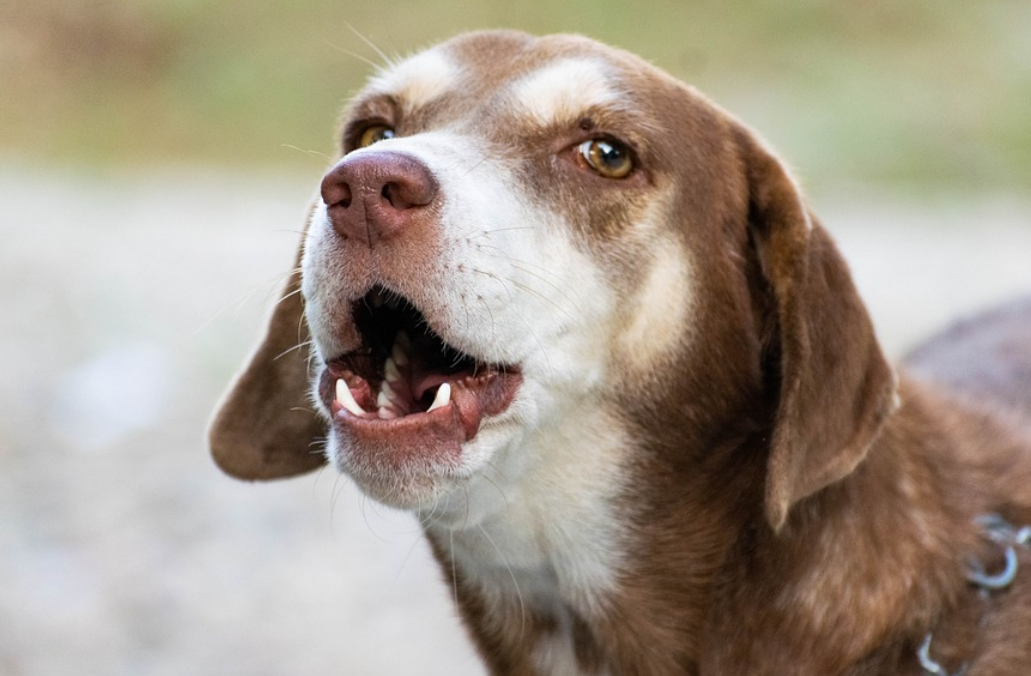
319,286,521,454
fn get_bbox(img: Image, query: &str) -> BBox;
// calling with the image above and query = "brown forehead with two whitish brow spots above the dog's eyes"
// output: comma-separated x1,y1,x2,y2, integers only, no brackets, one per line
364,32,677,126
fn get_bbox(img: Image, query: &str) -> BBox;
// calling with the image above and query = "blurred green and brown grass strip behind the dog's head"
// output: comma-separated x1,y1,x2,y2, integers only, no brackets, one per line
0,0,1031,194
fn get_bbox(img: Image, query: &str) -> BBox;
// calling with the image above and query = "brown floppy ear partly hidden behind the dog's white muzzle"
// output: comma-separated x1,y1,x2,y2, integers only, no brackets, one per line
208,240,326,481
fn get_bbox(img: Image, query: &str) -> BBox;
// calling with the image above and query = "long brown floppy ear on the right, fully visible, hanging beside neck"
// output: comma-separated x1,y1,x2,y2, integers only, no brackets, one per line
739,132,896,531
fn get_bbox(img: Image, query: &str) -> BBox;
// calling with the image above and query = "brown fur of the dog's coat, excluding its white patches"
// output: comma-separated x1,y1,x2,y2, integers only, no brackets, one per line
211,33,1031,676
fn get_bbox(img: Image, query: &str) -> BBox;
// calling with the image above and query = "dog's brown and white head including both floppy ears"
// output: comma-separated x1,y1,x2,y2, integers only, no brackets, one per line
211,33,894,527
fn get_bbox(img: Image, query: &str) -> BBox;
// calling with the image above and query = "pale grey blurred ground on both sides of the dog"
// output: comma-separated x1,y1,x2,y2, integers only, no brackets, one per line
0,167,1031,676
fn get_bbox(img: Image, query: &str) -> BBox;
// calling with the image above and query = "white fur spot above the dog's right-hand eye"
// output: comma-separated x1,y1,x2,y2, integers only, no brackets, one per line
511,59,620,126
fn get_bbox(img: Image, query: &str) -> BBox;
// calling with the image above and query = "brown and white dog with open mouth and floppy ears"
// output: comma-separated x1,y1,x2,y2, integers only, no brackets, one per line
210,32,1031,676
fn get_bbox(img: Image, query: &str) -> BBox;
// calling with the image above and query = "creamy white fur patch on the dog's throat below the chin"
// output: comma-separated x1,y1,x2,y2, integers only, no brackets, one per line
422,399,632,676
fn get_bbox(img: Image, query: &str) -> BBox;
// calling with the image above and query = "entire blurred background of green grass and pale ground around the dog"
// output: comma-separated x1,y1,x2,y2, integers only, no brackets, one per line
0,0,1031,676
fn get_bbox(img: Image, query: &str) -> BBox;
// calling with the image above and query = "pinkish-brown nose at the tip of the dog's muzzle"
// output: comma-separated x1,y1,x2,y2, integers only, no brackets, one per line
322,150,437,246
